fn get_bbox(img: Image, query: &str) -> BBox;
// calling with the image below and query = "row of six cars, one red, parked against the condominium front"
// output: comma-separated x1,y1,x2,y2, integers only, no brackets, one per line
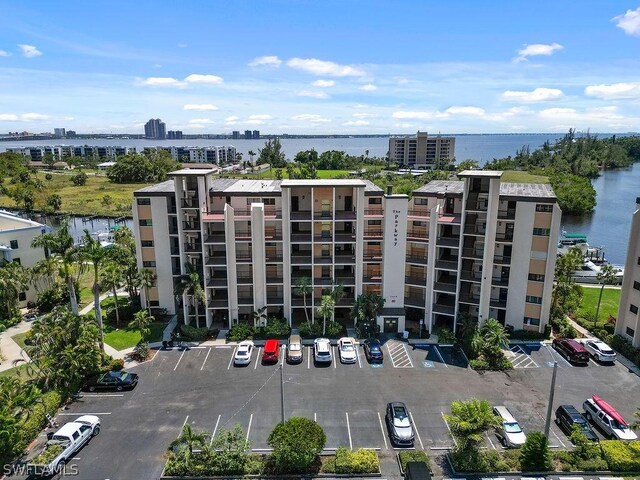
233,335,384,366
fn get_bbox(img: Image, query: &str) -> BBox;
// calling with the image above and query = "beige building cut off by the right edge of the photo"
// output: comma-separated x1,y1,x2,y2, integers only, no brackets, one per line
616,197,640,348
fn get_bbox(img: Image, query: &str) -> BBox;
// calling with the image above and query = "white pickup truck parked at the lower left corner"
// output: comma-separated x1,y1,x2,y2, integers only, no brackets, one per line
27,415,100,477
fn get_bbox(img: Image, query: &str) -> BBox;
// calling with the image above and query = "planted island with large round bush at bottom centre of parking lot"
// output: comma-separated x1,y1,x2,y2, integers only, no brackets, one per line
161,417,380,479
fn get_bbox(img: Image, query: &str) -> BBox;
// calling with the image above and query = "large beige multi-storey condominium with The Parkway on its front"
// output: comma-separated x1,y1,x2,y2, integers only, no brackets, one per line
133,169,561,332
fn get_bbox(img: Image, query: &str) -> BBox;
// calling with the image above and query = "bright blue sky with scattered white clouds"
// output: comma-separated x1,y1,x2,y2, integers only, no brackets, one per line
0,0,640,134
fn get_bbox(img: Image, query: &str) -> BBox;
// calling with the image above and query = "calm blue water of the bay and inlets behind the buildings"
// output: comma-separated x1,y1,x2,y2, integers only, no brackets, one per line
0,134,640,264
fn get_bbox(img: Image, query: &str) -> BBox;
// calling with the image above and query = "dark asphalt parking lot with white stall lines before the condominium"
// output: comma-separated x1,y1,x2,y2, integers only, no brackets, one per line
27,340,640,478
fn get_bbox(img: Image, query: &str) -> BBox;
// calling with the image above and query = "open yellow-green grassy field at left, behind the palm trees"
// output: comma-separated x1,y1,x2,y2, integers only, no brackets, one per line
0,169,154,217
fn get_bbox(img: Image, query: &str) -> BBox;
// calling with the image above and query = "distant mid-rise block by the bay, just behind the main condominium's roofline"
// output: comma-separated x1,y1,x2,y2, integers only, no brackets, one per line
389,132,456,170
